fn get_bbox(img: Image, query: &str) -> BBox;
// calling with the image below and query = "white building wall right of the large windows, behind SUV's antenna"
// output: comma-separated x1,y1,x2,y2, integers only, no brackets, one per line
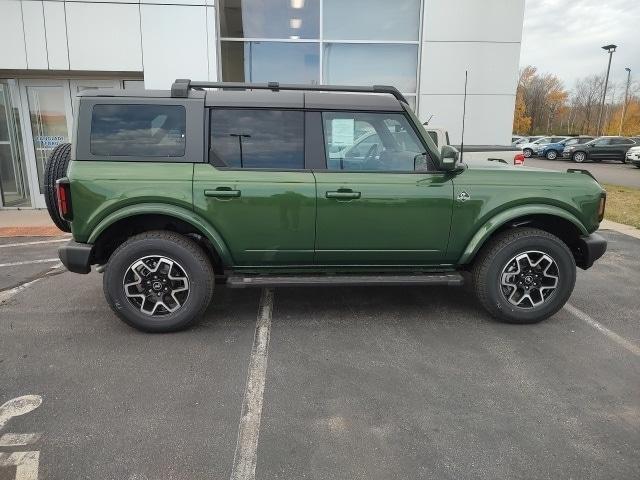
418,0,524,145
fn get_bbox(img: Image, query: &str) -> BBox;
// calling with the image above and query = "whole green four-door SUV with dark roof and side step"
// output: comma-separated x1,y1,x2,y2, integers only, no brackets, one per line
46,80,606,332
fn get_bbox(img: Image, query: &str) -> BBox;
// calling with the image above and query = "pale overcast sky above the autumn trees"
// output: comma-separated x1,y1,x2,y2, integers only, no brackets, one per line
520,0,640,96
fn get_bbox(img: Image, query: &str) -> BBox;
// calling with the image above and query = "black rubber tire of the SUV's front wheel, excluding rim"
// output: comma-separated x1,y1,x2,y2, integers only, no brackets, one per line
472,228,576,324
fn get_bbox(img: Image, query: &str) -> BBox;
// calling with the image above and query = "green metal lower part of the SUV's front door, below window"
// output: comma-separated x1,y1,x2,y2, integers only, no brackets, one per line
315,172,453,265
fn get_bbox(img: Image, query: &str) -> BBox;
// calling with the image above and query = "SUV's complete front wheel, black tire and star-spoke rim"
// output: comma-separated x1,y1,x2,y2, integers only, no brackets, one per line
472,228,576,324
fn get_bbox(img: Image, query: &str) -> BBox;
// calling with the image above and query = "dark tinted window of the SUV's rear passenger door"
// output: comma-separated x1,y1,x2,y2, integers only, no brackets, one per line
209,108,304,170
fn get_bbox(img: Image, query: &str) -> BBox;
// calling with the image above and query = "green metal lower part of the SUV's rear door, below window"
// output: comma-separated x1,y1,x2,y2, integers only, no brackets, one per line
193,164,316,266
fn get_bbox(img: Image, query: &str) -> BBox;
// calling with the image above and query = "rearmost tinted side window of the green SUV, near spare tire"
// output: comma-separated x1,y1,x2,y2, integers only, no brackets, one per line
90,105,186,157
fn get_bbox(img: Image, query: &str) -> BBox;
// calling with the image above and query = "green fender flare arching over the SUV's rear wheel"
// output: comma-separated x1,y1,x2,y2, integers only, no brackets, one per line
87,203,233,265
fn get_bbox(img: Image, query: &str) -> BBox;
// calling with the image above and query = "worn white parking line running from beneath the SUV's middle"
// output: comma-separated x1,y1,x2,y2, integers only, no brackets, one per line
231,288,273,480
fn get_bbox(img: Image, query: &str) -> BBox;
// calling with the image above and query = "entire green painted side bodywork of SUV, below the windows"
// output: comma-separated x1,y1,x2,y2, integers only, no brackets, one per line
68,154,603,272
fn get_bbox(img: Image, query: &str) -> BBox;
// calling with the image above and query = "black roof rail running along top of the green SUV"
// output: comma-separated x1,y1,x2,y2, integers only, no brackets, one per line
171,78,408,103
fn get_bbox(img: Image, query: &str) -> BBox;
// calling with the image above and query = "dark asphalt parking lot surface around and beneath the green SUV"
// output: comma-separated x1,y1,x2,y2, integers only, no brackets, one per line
0,231,640,480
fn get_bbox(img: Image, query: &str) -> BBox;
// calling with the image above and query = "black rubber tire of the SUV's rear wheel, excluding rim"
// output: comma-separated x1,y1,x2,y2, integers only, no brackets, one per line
103,231,215,332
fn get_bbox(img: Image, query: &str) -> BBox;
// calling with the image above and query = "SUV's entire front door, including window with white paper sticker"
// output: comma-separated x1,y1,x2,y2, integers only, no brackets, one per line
314,112,453,266
